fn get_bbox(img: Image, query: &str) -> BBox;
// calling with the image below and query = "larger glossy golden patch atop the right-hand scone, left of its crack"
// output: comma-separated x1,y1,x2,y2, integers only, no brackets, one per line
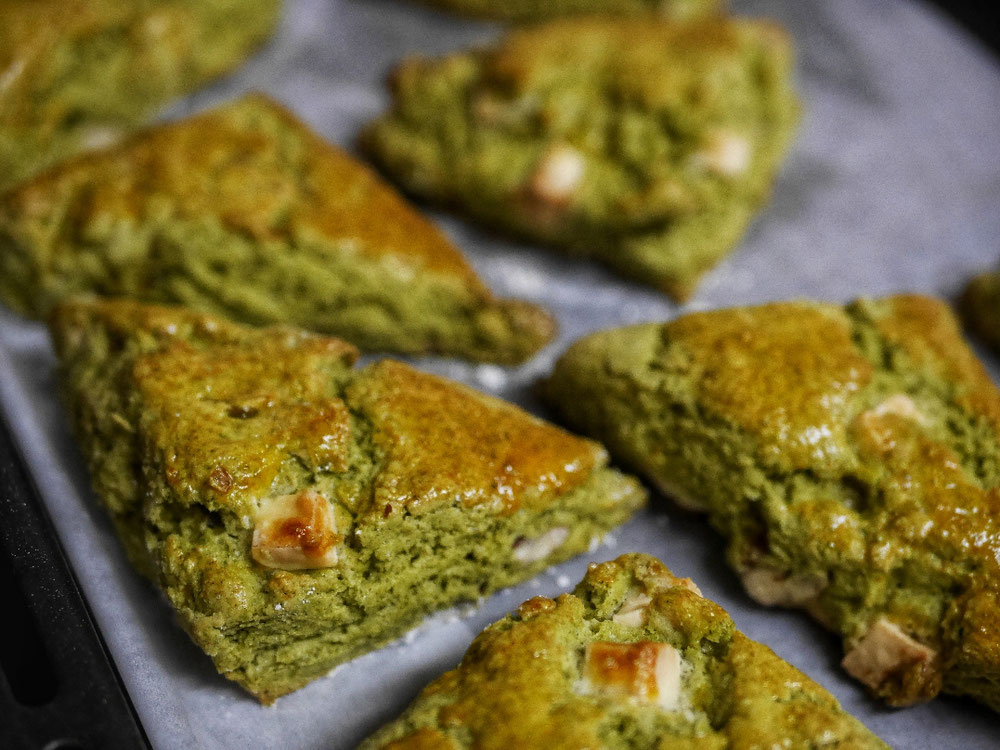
664,305,872,469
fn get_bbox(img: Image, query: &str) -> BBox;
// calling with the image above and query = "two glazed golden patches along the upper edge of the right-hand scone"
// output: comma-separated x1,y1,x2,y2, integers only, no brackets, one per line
664,297,1000,464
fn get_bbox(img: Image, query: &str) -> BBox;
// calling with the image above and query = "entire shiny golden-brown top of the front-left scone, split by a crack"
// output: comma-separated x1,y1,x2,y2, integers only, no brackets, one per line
53,301,607,525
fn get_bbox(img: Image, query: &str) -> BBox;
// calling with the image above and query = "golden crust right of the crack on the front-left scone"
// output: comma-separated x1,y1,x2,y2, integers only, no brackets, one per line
345,360,607,514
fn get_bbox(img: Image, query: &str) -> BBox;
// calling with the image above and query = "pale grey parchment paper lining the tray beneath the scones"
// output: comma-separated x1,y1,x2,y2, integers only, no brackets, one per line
0,0,1000,750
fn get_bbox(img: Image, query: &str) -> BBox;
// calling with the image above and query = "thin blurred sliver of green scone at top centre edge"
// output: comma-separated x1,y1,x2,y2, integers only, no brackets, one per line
414,0,724,23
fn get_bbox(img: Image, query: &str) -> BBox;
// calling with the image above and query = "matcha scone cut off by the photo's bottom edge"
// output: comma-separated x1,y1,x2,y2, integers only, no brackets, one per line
360,554,888,750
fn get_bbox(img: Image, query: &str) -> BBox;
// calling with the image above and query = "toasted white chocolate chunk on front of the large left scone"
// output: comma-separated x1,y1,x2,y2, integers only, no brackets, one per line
251,490,340,570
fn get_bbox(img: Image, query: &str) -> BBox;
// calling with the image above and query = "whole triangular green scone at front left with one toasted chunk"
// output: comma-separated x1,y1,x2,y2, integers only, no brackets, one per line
51,301,644,702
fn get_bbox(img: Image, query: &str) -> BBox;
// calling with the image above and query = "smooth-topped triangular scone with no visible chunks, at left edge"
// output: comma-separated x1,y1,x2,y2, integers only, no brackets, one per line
0,95,554,362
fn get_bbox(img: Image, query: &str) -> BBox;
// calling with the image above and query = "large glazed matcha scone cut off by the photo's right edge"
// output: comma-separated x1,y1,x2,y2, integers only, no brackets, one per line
546,296,1000,710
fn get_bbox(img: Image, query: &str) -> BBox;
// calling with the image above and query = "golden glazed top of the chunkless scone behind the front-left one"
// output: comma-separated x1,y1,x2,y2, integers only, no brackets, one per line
0,95,488,284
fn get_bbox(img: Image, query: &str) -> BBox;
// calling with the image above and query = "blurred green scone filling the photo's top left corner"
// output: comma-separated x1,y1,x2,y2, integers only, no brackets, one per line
0,0,281,192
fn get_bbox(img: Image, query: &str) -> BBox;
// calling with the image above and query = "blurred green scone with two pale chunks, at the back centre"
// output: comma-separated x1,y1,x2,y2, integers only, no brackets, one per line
362,17,799,299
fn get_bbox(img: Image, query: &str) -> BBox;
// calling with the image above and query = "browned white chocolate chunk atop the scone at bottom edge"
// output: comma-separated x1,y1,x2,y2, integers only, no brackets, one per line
584,641,681,711
